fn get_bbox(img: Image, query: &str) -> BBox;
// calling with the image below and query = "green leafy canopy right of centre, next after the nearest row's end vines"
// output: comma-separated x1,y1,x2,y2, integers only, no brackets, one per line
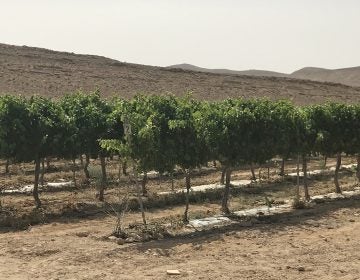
196,99,284,167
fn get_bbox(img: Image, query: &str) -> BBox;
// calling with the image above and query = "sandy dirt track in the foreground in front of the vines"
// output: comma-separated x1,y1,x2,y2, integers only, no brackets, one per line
0,200,360,279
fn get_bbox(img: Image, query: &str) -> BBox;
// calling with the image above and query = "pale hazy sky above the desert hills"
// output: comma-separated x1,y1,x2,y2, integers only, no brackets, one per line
0,0,360,72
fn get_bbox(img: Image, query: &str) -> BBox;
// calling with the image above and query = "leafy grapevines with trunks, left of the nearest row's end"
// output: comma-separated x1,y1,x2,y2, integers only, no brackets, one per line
0,92,122,207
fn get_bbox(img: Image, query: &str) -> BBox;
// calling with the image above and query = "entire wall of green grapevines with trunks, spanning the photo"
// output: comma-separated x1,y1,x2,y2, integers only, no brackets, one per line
0,92,360,221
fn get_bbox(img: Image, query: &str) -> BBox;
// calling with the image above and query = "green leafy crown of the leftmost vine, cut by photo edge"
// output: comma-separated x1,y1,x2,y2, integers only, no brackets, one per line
0,96,69,161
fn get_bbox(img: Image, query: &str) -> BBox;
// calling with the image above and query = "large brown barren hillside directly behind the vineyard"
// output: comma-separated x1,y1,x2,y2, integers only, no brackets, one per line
0,44,360,104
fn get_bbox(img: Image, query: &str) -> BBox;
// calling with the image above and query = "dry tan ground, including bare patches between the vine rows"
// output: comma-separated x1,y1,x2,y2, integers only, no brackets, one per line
0,157,360,279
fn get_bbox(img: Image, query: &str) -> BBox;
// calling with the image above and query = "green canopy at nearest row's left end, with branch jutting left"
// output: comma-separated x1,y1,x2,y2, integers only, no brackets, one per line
102,95,205,173
